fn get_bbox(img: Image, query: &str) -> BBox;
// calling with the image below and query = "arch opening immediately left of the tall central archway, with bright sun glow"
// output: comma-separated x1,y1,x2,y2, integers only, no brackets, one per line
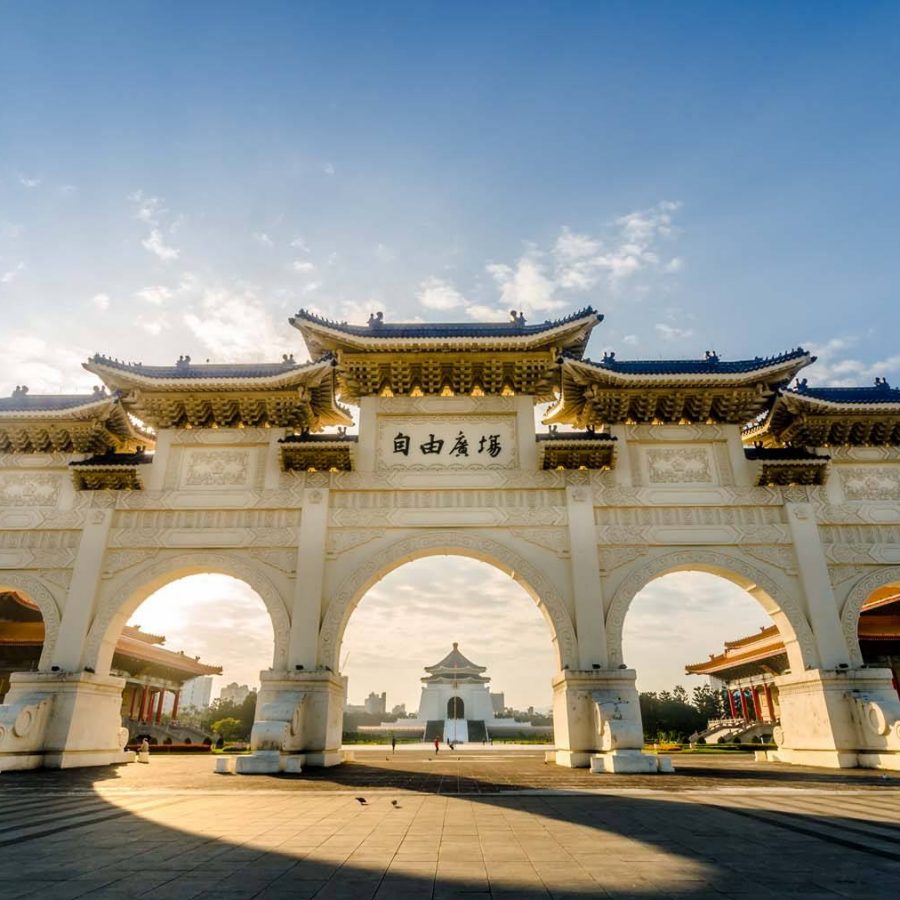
100,573,274,750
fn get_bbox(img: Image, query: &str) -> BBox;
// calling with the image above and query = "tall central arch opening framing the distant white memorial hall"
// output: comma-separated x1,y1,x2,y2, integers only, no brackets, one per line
340,555,559,745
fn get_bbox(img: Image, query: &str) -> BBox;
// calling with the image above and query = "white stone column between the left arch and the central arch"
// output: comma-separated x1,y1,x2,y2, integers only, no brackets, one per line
288,487,329,671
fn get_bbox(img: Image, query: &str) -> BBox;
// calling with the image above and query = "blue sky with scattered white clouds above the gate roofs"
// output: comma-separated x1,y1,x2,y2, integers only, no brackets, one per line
0,2,900,704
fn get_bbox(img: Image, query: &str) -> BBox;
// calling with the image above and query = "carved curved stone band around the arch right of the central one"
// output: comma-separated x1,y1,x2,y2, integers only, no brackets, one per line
606,549,817,667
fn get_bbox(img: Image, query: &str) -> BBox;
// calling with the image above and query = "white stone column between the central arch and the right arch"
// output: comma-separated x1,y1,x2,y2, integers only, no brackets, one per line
566,484,609,670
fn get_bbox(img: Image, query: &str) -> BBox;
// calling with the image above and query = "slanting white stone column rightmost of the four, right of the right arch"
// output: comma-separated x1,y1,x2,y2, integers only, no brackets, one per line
788,502,850,669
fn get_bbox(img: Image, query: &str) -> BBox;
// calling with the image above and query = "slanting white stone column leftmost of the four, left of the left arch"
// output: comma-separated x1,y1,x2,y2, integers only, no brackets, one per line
50,509,113,672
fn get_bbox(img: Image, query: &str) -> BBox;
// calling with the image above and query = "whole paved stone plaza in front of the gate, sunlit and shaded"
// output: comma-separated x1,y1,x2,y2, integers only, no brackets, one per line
0,748,900,900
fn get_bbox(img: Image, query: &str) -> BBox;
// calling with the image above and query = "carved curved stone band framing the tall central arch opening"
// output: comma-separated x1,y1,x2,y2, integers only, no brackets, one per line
319,531,578,672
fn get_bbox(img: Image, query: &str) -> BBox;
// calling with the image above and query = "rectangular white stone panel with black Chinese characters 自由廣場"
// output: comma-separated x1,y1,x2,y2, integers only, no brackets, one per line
376,416,518,470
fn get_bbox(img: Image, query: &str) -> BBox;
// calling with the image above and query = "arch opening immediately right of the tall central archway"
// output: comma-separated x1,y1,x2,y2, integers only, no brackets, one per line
622,565,810,749
